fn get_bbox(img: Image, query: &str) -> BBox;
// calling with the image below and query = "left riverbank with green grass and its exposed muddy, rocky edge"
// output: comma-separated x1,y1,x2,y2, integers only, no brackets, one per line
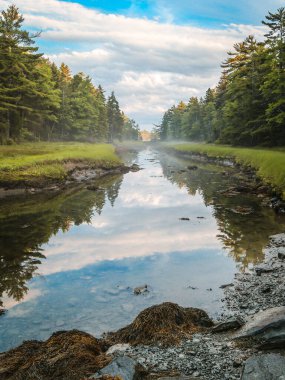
0,143,136,196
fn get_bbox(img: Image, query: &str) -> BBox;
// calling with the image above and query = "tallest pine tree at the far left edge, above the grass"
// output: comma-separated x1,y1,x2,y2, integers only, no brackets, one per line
0,5,42,141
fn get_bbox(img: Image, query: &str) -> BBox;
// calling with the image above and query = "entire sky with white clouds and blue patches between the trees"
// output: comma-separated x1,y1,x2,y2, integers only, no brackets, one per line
0,0,285,130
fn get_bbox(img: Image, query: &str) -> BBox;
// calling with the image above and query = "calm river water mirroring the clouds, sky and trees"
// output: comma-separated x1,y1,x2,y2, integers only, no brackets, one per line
0,149,285,351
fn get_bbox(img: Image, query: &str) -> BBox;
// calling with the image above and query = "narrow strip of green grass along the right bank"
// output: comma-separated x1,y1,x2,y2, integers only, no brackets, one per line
167,143,285,199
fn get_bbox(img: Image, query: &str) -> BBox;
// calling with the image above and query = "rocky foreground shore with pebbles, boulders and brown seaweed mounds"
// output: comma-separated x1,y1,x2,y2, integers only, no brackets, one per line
0,234,285,380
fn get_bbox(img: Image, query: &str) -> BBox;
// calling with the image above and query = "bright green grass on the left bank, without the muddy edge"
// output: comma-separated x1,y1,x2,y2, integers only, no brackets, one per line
0,143,121,184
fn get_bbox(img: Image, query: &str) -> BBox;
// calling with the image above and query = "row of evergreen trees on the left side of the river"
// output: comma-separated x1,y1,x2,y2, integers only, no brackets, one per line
0,5,139,144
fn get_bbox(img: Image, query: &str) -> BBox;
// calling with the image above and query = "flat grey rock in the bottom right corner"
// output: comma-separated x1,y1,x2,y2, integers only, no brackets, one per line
241,354,285,380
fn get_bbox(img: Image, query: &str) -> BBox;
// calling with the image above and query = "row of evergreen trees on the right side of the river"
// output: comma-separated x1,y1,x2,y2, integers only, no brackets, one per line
156,7,285,146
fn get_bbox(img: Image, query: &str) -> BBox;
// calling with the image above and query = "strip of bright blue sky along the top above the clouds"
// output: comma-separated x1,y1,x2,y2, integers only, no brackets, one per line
61,0,284,27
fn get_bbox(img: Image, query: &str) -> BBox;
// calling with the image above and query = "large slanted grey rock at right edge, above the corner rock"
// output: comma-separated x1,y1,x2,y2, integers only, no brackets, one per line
236,306,285,348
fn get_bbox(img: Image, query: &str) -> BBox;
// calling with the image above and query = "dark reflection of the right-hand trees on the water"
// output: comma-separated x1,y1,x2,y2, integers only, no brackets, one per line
160,151,285,271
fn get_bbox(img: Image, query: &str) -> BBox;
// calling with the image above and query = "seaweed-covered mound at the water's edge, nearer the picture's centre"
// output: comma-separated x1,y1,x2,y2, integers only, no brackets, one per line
106,302,213,346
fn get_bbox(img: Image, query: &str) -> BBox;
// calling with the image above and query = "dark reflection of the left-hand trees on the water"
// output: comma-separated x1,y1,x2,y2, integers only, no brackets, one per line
0,176,122,307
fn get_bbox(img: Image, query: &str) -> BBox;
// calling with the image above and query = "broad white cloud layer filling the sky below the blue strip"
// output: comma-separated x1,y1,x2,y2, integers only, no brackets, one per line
0,0,263,127
